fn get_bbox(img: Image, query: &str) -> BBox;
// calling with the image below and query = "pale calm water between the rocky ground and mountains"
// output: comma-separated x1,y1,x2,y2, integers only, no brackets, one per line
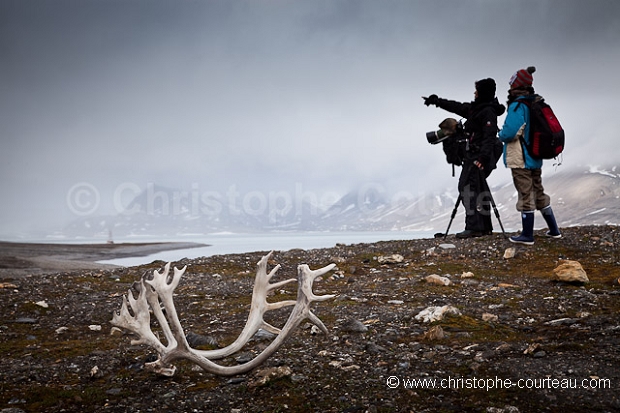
99,231,433,267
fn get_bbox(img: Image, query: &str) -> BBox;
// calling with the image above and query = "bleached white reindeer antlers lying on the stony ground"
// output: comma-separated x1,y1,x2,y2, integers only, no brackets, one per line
111,251,335,376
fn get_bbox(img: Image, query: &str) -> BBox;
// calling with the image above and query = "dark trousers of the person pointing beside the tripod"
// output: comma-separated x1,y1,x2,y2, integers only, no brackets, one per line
458,162,493,233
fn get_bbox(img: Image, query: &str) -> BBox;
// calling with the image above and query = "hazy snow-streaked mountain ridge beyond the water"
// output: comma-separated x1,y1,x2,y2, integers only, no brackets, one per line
60,166,620,238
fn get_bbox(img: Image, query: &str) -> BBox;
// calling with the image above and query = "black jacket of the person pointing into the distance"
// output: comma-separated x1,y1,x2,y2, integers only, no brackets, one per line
437,98,506,174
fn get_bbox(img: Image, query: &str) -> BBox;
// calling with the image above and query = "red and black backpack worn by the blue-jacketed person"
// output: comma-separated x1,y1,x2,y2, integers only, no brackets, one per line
520,97,564,159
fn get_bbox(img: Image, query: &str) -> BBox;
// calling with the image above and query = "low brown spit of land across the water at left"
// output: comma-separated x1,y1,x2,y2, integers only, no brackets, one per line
0,241,208,279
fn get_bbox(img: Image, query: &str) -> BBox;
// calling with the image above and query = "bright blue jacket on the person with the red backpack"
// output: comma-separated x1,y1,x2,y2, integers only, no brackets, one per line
498,95,542,169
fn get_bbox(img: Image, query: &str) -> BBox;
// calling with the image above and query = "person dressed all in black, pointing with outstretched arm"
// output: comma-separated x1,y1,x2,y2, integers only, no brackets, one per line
423,78,506,239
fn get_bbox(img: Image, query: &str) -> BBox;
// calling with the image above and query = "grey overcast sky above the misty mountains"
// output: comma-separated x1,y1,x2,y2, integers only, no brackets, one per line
0,0,620,236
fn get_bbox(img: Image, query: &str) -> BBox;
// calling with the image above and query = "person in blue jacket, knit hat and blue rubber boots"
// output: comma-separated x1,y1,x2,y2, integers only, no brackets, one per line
499,66,562,245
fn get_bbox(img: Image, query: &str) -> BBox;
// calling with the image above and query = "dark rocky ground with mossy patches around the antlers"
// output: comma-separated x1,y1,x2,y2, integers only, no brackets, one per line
0,226,620,412
